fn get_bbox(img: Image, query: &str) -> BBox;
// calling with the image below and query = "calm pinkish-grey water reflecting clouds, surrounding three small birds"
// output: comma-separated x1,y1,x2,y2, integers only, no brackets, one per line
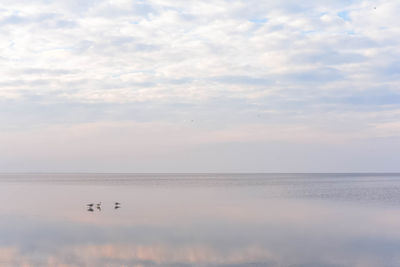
0,174,400,267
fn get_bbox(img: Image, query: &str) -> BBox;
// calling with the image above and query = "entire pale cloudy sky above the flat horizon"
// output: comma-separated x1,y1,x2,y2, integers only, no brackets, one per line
0,0,400,172
